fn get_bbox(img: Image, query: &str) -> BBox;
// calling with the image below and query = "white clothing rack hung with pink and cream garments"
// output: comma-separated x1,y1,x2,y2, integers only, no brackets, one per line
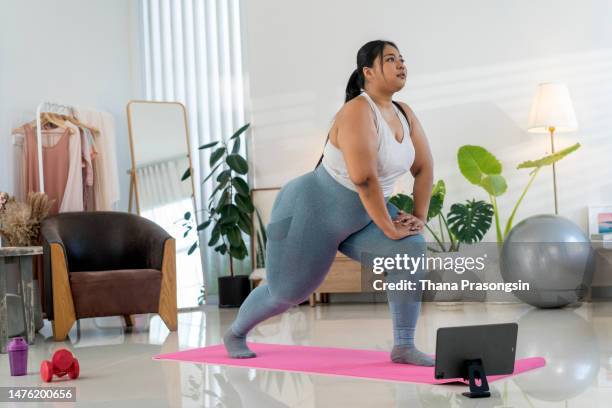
11,99,120,212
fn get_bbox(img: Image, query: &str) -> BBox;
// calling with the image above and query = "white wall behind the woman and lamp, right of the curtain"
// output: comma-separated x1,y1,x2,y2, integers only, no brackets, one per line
244,0,612,239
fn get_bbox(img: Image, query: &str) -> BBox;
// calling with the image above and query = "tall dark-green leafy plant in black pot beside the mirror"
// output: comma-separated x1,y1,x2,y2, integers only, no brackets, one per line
183,123,254,307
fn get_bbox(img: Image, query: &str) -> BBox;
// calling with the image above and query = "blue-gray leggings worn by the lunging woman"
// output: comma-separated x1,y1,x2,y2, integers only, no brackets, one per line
231,165,426,336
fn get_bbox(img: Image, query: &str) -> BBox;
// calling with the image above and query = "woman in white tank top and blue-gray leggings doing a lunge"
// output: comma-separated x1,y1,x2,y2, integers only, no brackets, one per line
223,40,433,366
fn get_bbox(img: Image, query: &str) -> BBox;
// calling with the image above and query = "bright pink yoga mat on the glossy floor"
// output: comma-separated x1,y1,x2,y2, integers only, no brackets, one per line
153,342,546,384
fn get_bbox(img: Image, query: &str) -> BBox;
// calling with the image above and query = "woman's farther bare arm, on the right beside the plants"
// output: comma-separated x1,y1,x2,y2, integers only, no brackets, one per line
400,102,433,223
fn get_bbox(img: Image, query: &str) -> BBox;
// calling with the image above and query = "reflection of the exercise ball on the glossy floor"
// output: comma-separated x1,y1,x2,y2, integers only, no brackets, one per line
514,308,600,406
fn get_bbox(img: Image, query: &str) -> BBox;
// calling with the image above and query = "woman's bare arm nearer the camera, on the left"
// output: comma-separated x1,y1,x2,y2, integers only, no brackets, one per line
336,98,398,239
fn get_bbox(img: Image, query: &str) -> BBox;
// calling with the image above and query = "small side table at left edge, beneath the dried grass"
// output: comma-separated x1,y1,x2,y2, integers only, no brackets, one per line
0,246,43,353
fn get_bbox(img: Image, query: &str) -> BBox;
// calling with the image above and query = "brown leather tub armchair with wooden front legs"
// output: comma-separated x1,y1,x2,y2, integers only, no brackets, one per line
41,212,177,341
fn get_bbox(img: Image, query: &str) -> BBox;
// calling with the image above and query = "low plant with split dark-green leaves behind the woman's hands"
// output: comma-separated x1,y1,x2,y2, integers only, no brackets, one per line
389,180,493,252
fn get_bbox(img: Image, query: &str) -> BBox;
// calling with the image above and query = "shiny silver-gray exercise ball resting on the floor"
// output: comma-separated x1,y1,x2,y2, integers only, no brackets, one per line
500,214,595,308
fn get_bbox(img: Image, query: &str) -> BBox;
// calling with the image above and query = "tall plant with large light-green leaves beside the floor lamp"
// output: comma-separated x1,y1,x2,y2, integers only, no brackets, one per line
457,143,580,244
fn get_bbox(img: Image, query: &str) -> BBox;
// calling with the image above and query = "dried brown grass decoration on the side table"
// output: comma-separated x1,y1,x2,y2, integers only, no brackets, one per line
0,192,52,246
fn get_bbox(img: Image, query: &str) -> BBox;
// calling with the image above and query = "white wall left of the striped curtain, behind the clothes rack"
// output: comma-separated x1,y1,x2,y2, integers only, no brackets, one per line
0,0,139,209
